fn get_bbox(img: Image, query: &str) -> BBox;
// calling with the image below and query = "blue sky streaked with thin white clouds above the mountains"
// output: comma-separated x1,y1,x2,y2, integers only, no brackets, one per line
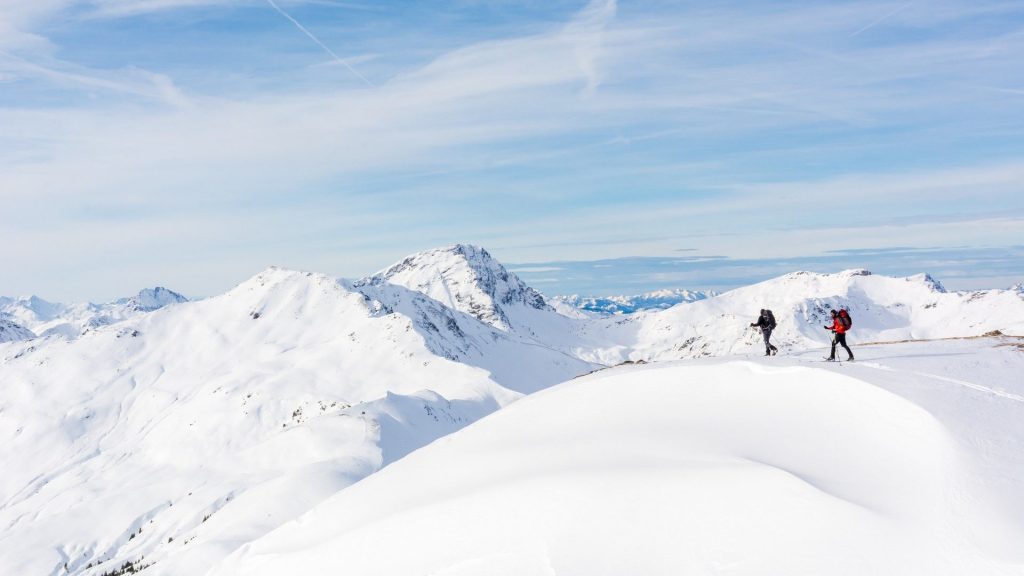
0,0,1024,300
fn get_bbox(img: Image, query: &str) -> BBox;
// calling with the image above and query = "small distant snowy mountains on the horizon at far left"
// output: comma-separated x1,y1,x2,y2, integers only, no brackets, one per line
0,287,188,338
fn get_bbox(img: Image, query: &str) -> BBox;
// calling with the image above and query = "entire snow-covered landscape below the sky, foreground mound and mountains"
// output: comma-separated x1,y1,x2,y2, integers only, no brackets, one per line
0,245,1024,576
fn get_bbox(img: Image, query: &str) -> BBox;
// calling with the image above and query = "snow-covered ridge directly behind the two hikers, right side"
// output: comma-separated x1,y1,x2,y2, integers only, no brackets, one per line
585,270,1024,364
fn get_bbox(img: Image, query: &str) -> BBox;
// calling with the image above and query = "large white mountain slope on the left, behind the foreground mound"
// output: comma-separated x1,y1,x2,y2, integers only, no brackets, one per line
0,269,592,574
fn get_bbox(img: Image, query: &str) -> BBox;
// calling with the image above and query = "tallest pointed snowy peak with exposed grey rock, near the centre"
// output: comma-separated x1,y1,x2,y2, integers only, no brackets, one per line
355,244,551,331
